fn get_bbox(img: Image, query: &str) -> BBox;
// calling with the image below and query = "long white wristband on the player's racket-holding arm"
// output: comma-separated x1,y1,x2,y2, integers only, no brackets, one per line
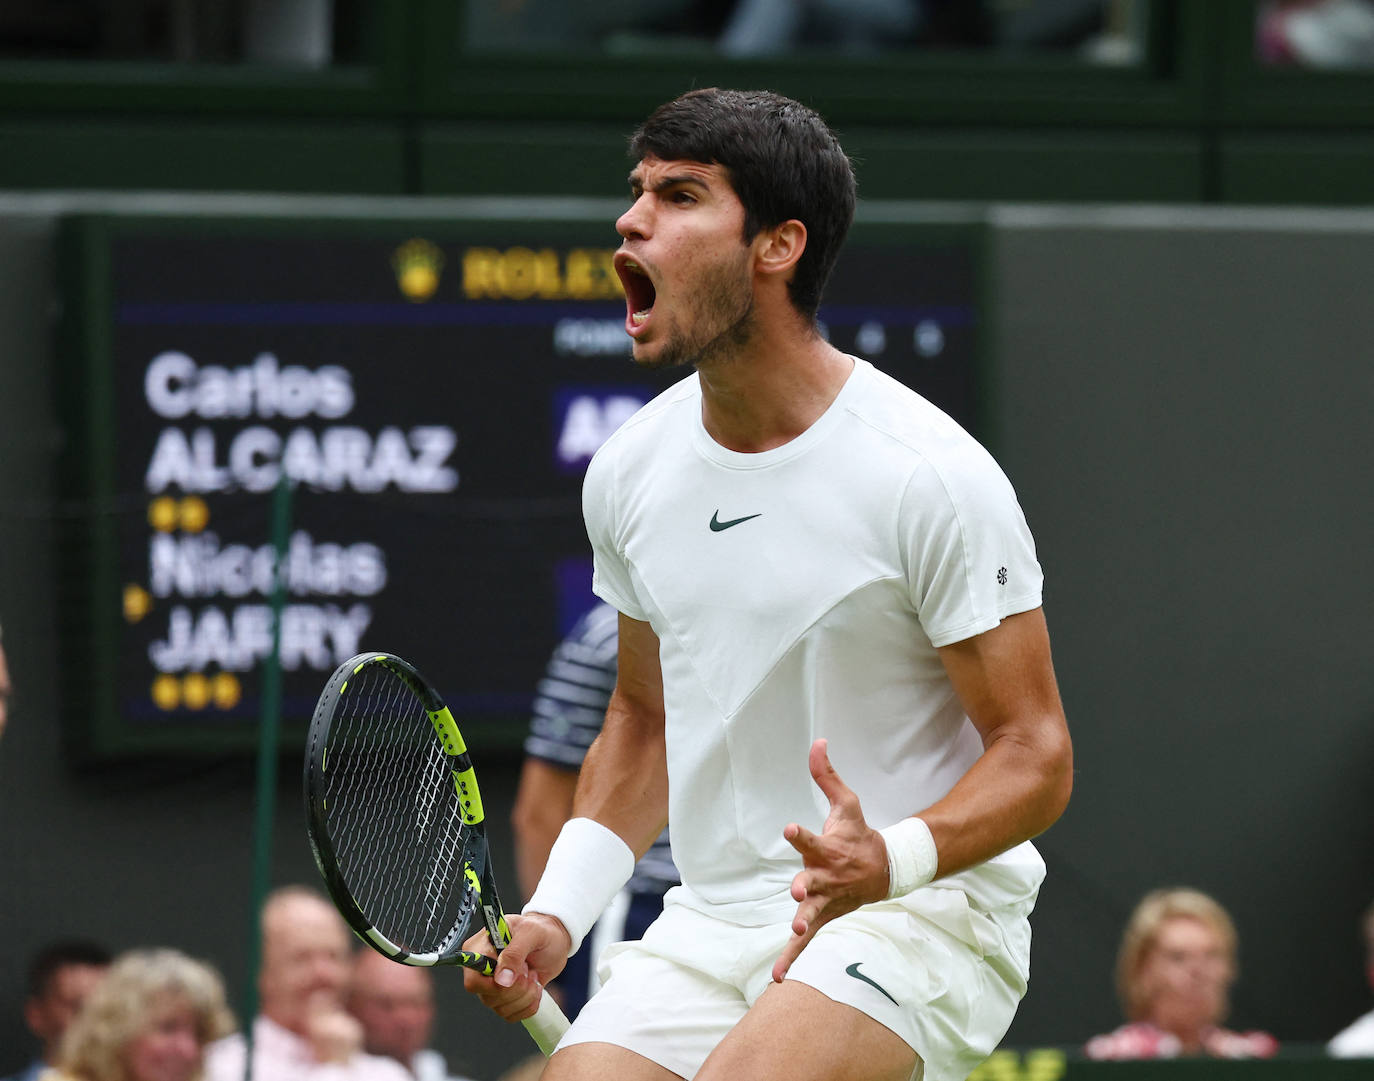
521,819,635,957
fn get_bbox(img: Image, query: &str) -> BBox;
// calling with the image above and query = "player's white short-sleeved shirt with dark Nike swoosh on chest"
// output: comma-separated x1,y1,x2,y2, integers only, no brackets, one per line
583,360,1044,924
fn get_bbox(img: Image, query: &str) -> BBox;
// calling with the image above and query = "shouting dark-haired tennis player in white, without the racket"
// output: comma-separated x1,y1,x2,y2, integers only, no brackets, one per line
464,89,1072,1081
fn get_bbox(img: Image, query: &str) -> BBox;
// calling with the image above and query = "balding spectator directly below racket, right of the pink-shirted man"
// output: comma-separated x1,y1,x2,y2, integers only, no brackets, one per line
348,949,478,1081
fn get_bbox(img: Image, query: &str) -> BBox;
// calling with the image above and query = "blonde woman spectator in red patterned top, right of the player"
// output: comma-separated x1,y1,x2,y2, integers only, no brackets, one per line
1084,889,1279,1059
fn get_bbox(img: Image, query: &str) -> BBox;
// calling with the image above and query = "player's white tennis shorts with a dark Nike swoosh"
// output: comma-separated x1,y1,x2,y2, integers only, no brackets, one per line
559,887,1031,1081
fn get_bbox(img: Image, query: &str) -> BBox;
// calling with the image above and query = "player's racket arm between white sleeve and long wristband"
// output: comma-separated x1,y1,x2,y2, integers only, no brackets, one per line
573,615,668,858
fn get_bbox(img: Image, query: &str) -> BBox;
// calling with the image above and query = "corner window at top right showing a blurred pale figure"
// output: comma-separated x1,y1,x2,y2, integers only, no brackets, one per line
1254,0,1374,67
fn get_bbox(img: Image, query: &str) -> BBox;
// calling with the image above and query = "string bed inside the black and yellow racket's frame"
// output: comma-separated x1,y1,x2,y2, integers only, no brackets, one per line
324,665,477,953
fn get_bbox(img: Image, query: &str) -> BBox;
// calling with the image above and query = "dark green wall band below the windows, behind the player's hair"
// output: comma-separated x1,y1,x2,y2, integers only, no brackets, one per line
0,0,1374,205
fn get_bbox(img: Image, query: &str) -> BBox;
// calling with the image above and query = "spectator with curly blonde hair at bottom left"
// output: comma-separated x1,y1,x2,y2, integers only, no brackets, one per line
45,949,234,1081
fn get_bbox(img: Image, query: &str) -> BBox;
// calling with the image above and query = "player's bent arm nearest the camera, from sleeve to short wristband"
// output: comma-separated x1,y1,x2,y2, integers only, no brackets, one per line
915,608,1073,875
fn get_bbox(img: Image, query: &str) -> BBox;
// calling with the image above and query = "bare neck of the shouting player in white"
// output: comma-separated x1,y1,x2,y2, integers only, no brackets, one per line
698,326,853,453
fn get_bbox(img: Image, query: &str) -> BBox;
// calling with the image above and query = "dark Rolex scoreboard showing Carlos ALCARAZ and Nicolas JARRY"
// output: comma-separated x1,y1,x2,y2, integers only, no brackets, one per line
50,213,978,758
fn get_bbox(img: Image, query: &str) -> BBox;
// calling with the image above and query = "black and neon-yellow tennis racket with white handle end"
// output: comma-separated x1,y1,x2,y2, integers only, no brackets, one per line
305,652,567,1055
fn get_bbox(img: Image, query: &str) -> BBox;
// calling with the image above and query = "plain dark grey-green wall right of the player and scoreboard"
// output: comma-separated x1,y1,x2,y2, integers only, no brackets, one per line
991,207,1374,1040
